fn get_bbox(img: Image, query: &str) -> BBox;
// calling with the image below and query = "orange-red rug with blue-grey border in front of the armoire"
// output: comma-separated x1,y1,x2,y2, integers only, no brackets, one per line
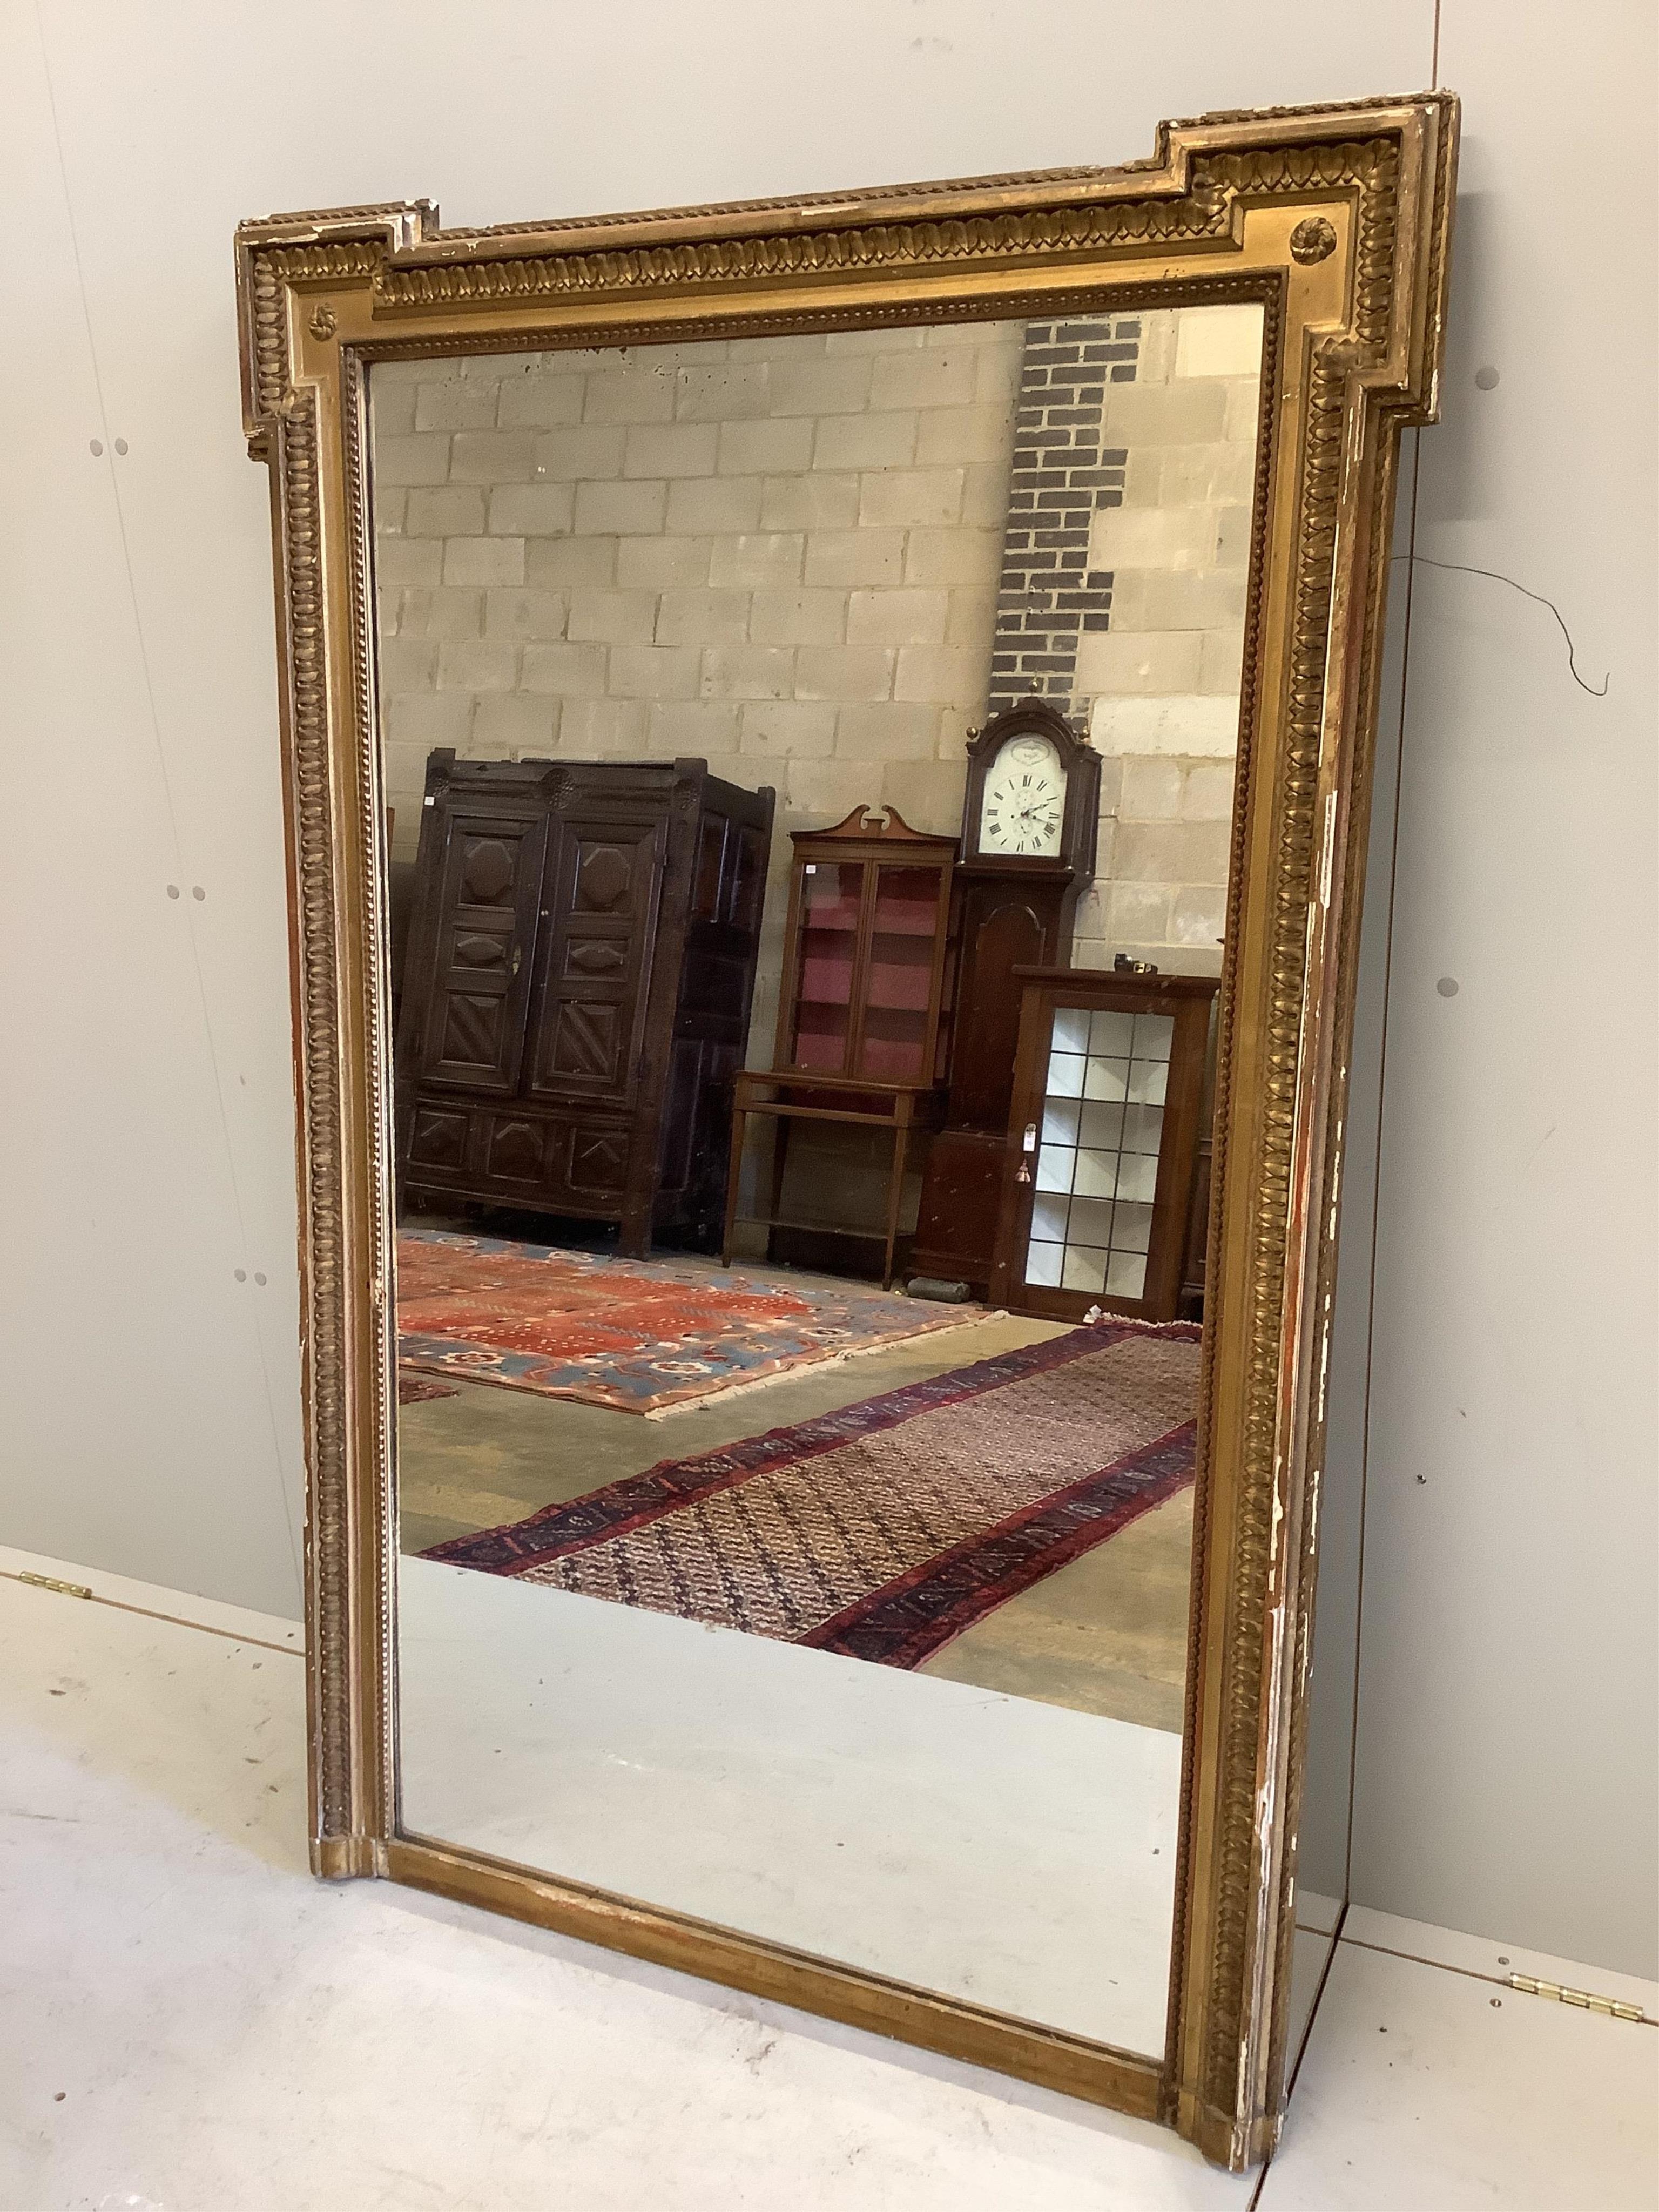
398,1230,987,1415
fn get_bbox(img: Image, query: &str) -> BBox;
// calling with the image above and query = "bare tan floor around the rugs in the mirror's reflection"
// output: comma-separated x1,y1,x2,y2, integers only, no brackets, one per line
398,1267,1192,1732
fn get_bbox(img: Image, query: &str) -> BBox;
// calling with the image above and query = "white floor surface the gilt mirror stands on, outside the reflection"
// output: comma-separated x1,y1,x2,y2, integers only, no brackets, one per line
0,1553,1659,2212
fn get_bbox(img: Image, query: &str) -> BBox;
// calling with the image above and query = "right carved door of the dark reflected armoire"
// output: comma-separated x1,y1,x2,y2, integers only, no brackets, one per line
529,816,666,1108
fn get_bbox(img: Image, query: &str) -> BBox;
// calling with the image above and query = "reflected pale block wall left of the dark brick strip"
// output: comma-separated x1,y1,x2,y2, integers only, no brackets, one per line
372,323,1022,1064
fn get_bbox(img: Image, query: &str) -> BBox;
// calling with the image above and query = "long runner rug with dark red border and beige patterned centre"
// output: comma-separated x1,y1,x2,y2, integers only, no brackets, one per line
422,1320,1201,1668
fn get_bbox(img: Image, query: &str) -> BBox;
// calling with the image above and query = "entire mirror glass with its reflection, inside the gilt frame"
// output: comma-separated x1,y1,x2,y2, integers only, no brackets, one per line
369,305,1261,2053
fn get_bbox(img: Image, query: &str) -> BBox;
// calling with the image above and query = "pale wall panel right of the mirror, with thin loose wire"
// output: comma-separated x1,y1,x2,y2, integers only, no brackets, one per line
1354,0,1659,1975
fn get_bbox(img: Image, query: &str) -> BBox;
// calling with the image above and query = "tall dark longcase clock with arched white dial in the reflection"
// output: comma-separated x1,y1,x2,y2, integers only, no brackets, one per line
909,699,1100,1292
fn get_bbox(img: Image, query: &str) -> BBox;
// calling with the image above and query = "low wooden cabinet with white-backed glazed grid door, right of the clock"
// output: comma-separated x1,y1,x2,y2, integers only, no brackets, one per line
991,969,1221,1320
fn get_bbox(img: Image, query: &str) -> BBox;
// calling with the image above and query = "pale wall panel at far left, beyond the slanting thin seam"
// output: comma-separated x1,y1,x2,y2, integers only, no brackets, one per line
0,18,299,1613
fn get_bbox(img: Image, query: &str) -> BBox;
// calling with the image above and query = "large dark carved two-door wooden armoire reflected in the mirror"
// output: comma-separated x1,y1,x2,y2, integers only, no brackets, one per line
396,750,772,1257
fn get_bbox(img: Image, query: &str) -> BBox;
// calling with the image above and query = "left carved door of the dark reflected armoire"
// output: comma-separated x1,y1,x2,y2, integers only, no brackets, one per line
420,807,547,1095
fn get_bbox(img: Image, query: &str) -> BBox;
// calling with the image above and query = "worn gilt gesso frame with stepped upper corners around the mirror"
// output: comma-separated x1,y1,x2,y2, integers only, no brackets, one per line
237,95,1458,2168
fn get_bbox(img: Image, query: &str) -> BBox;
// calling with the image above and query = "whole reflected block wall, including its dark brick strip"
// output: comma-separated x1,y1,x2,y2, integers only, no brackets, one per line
372,307,1261,1106
